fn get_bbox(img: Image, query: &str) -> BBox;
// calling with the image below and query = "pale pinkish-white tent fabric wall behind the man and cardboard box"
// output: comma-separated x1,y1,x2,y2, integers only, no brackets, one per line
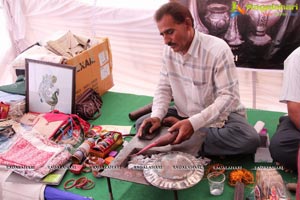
3,0,286,111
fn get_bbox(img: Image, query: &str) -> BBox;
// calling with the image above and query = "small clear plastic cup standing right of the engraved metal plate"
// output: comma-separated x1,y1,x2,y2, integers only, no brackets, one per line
207,172,225,196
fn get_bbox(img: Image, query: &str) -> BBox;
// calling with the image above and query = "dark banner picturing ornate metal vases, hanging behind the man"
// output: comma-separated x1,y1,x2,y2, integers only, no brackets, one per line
190,0,300,69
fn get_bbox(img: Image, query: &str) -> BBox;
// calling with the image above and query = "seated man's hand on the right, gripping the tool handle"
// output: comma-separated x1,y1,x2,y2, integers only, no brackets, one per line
168,119,194,144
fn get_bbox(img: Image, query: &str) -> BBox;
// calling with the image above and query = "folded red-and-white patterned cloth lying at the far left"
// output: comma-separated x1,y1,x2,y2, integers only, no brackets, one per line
0,131,71,179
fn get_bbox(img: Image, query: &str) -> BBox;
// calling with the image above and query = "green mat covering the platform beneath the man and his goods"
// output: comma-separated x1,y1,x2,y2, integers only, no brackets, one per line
57,92,297,200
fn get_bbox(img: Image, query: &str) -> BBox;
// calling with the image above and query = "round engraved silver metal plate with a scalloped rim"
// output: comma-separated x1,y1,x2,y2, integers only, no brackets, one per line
143,151,204,190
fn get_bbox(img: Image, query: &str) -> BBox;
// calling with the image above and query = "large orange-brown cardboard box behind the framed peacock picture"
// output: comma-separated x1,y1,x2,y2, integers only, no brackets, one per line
66,38,114,98
